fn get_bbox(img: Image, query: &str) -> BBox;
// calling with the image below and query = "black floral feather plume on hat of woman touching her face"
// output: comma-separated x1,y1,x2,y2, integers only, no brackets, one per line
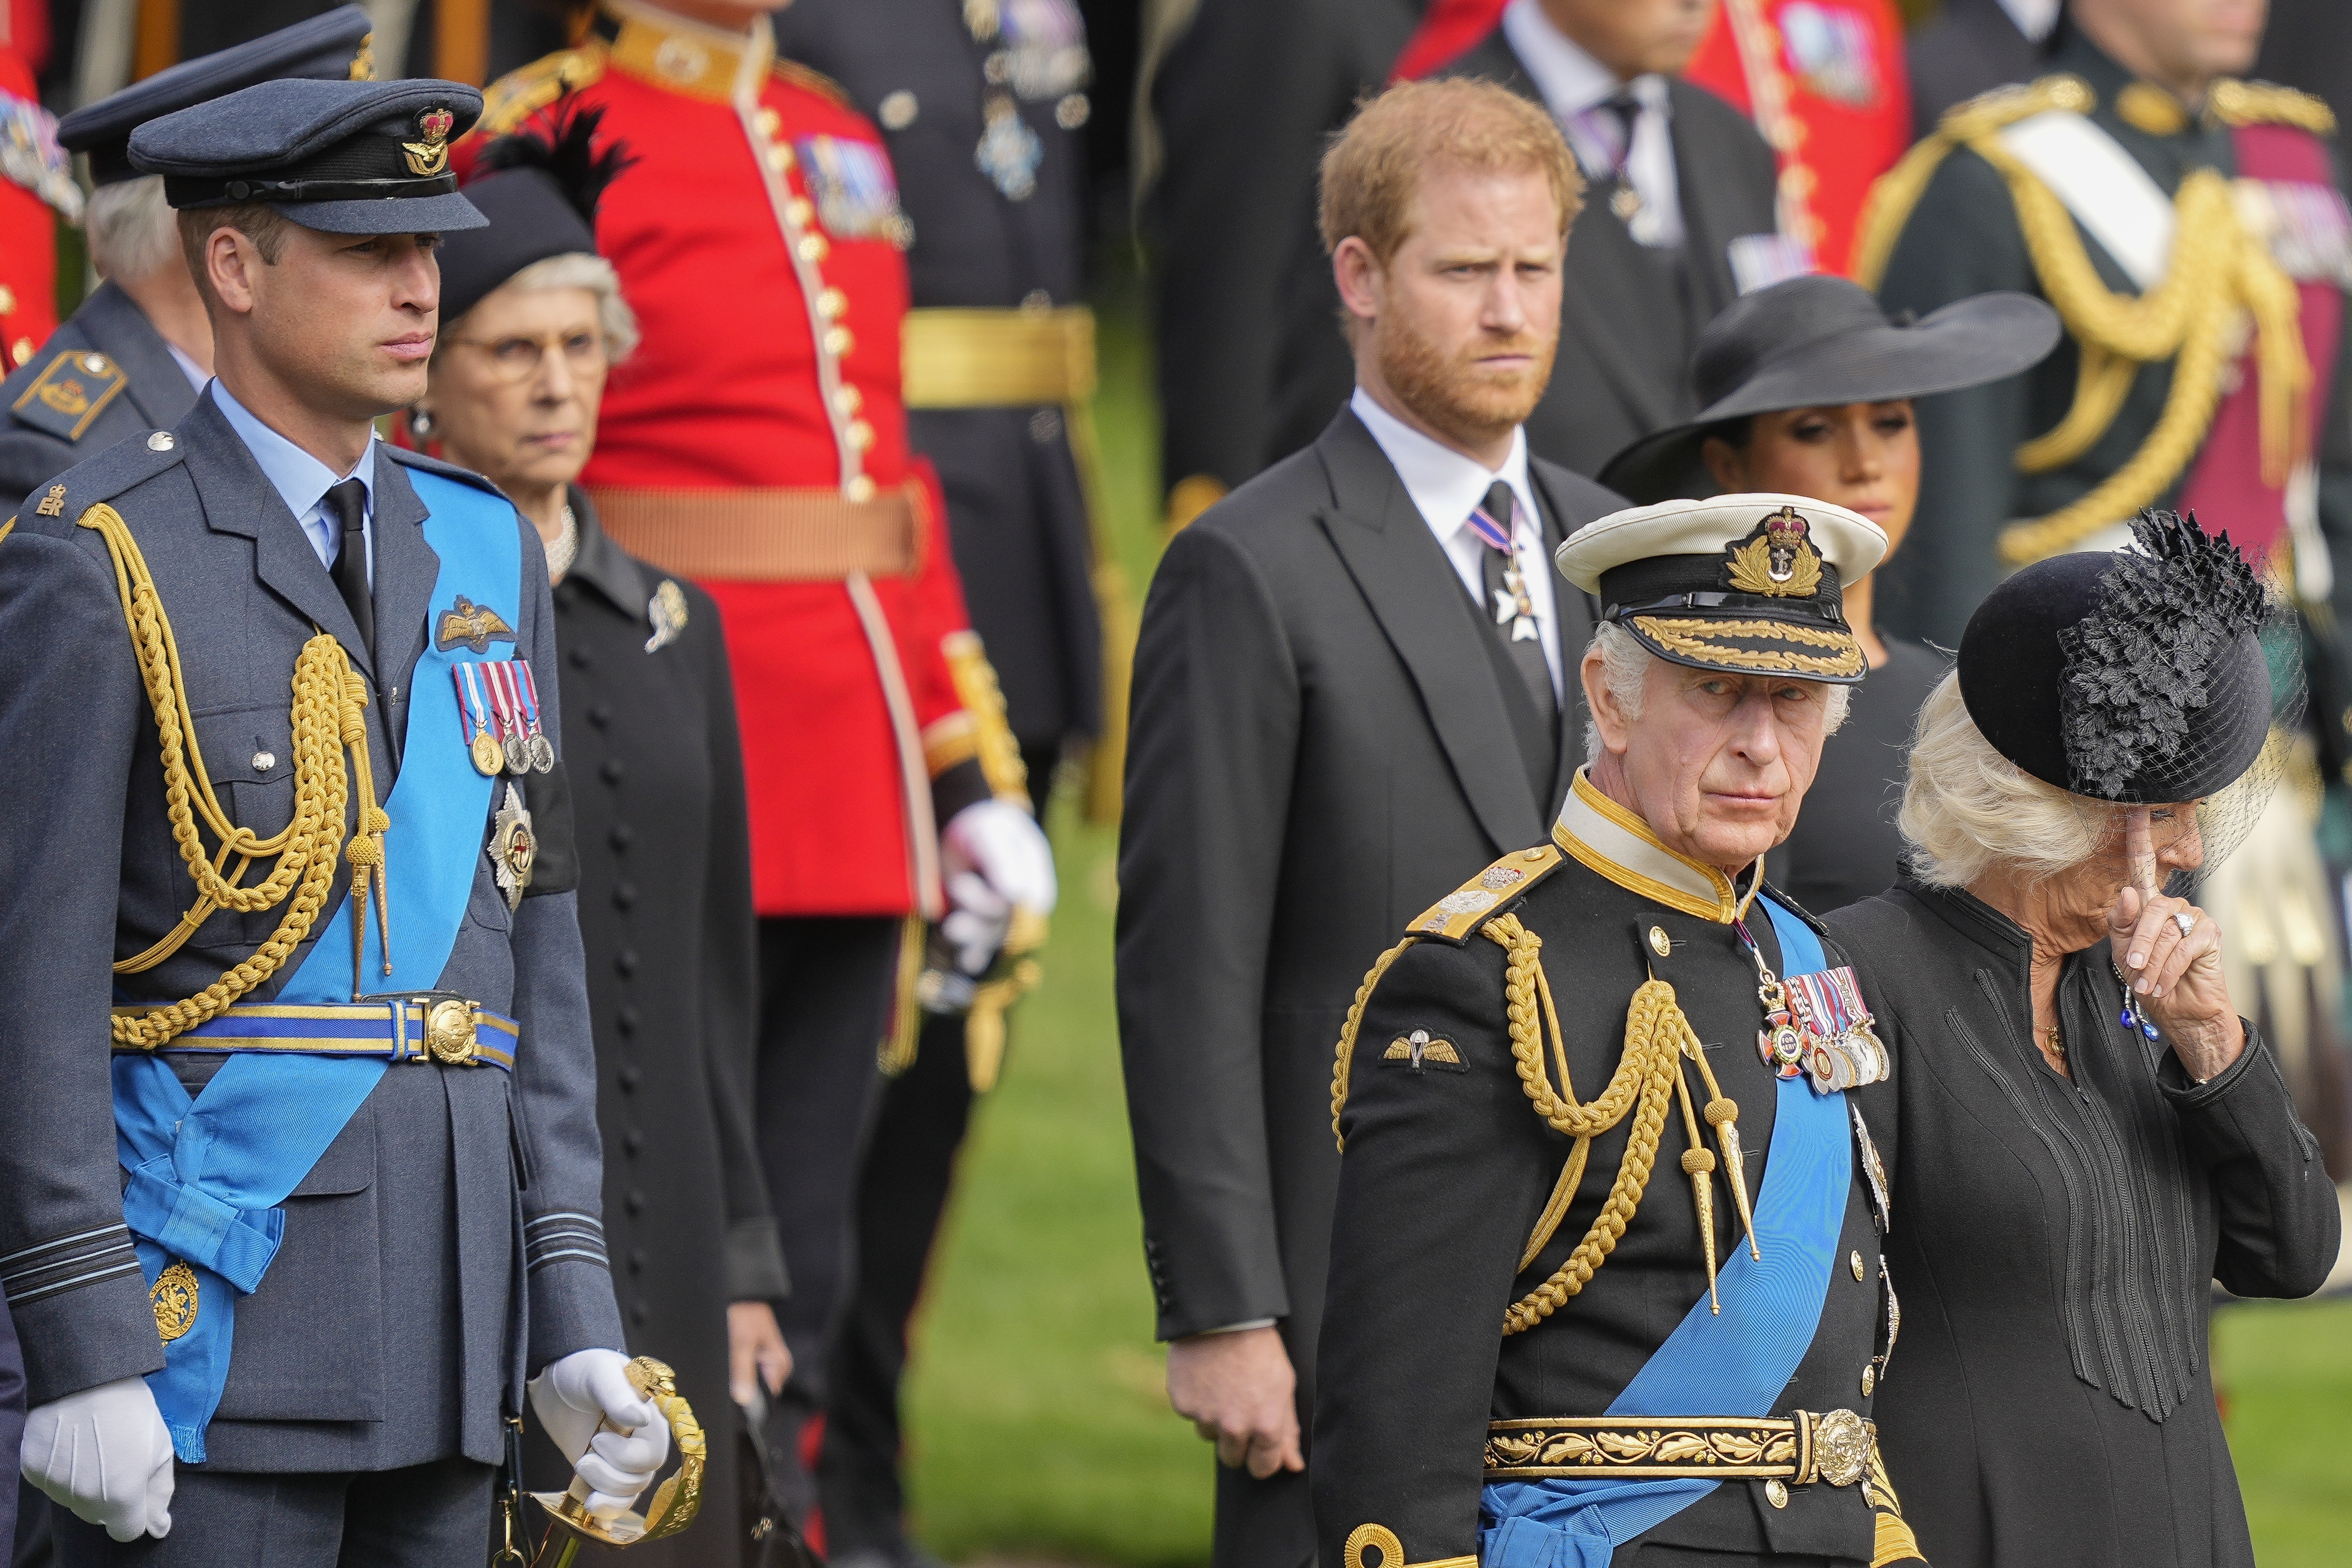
2058,508,2263,799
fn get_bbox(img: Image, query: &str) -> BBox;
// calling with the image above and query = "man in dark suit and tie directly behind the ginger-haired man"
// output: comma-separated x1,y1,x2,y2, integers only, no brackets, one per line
1326,0,1804,475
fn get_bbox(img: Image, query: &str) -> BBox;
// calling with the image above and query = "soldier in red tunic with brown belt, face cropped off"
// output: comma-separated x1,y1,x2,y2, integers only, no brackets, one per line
482,0,1054,1504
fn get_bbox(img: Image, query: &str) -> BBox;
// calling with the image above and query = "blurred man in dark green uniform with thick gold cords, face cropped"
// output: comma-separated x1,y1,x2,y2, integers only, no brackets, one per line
1858,0,2352,1178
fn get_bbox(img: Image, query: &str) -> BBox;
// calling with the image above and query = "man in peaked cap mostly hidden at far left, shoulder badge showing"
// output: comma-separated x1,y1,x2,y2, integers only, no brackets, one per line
0,5,369,510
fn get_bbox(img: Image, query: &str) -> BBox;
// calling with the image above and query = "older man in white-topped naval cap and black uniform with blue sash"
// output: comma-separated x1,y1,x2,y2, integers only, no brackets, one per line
1310,494,1919,1568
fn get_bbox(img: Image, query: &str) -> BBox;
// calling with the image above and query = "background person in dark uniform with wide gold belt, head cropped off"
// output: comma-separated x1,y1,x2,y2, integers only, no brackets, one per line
776,0,1100,1568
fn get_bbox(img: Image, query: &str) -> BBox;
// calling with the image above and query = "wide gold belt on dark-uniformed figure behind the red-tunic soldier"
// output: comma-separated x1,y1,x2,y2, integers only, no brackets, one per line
898,306,1094,409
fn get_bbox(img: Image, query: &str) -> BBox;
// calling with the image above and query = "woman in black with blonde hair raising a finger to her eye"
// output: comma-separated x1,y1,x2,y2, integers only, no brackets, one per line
1825,513,2340,1568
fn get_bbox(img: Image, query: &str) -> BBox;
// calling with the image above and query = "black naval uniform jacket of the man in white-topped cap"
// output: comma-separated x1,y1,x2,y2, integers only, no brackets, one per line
1313,809,1900,1568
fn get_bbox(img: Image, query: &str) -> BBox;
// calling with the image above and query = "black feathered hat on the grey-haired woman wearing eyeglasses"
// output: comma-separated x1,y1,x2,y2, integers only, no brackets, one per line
435,108,635,322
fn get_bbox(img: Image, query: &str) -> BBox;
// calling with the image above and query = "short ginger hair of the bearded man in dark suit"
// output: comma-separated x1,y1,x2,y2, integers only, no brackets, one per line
1317,78,1585,266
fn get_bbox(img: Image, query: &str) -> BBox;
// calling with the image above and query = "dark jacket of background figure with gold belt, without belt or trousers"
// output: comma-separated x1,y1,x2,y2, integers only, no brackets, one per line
776,0,1103,752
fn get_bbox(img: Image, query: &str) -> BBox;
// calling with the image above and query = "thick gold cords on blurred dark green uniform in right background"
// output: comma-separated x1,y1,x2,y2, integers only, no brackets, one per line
1853,75,2312,567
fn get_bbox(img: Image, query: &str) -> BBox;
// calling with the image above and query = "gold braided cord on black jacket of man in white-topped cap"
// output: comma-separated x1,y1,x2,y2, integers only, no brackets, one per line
1331,915,1762,1335
